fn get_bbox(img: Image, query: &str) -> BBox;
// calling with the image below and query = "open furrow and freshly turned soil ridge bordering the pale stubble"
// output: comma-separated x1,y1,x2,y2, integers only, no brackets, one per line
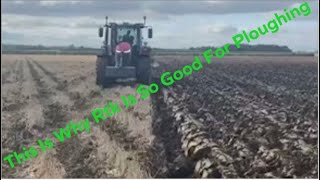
153,87,238,178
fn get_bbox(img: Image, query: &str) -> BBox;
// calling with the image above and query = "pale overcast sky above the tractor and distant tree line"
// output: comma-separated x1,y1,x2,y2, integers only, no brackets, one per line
1,0,319,51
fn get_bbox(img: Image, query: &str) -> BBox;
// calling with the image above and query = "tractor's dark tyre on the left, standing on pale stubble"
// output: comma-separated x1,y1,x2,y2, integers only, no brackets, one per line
96,57,113,87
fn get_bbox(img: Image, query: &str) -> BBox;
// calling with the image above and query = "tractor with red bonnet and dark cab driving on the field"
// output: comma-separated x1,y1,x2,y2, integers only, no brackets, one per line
96,16,152,87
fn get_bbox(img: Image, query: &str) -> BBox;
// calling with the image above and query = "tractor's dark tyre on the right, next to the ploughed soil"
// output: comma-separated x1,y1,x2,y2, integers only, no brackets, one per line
136,57,152,85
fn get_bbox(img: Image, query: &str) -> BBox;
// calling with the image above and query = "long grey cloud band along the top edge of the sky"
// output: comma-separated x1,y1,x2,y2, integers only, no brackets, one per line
3,1,318,18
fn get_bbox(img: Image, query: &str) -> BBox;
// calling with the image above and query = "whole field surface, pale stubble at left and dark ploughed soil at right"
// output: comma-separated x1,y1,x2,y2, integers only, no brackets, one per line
1,55,318,178
